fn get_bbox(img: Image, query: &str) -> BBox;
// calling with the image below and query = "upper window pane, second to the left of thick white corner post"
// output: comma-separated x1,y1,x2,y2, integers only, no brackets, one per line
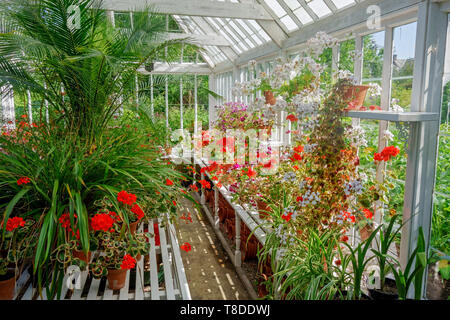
363,31,385,81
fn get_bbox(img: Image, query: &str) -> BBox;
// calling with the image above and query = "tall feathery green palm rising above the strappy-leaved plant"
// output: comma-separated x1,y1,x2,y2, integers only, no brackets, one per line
0,0,178,143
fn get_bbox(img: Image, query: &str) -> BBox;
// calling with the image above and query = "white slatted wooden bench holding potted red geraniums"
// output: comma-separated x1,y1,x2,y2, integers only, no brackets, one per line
14,219,191,300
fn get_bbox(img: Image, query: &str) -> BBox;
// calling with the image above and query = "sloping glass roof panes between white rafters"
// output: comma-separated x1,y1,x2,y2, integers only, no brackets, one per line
174,0,364,66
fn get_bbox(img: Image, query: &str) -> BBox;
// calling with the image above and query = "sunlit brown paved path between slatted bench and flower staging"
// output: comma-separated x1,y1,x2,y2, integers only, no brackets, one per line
177,200,249,300
